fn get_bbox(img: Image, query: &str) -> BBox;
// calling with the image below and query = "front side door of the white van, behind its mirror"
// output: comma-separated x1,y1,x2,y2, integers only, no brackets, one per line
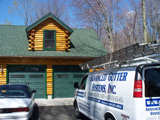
77,75,90,116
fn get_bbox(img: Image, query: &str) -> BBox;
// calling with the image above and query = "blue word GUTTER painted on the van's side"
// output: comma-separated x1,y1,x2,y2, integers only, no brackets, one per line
108,72,128,81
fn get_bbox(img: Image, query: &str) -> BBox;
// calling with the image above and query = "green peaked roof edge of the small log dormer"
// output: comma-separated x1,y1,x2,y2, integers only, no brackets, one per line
26,12,73,33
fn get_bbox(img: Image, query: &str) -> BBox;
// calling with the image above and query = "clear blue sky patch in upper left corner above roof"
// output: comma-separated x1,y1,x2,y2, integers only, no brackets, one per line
0,0,24,25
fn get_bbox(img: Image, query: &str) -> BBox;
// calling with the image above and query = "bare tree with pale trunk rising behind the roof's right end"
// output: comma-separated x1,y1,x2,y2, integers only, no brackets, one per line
72,0,122,52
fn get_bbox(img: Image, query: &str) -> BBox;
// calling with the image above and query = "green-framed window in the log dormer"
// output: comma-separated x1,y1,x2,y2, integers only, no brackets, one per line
43,30,56,50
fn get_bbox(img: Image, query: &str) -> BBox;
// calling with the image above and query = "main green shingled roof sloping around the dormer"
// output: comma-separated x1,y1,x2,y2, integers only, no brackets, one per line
0,25,107,58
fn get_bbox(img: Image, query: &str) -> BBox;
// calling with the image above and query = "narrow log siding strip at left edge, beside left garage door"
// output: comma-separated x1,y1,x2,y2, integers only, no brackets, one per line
0,65,7,85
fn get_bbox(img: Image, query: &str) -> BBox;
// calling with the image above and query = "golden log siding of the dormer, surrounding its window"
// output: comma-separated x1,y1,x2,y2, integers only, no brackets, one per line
28,18,70,51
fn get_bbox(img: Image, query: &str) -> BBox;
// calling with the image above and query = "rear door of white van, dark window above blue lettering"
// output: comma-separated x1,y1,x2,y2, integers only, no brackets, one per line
143,66,160,120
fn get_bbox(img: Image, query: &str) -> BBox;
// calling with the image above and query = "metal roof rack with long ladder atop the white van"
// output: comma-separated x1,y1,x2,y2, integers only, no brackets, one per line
79,42,160,70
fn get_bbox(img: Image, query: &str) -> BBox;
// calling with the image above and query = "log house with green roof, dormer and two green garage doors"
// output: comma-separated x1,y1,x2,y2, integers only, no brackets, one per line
0,13,107,99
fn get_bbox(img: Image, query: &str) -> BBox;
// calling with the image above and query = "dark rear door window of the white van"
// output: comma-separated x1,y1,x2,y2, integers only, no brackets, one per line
145,68,160,97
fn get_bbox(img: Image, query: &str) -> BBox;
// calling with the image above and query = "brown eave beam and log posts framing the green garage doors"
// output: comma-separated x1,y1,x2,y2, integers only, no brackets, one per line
0,58,90,95
